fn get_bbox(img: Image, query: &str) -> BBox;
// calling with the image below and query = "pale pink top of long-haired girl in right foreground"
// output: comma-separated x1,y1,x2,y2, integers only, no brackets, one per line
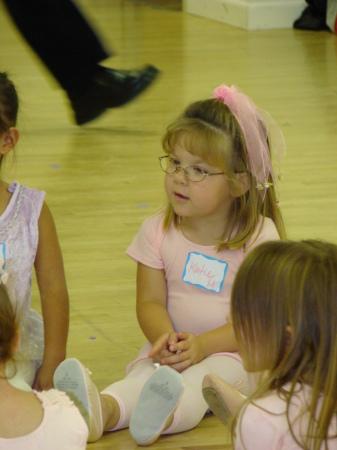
235,386,337,450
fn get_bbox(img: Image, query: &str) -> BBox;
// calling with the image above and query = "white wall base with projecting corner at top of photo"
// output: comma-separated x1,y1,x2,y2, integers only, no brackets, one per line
183,0,307,30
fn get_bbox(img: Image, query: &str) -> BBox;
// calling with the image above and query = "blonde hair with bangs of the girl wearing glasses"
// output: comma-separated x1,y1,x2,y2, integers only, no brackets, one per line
162,99,285,251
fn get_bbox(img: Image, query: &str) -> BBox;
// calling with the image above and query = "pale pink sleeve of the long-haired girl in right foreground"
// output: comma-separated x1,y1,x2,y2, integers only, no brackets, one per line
234,404,284,450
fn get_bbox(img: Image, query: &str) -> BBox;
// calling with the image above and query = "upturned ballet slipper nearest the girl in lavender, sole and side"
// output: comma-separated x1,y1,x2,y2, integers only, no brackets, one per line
54,358,103,442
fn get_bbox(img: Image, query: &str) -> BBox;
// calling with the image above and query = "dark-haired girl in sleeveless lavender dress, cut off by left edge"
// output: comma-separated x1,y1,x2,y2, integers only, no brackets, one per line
0,72,69,390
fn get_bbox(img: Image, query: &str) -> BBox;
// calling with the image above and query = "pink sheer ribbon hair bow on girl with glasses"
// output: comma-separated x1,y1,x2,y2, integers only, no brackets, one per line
213,84,286,199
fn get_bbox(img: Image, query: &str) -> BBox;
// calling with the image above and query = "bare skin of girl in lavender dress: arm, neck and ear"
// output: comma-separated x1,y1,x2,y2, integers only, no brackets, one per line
0,127,69,390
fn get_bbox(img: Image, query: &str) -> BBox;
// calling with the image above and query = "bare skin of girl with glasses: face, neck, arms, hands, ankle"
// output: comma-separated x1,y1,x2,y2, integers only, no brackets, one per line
97,142,248,430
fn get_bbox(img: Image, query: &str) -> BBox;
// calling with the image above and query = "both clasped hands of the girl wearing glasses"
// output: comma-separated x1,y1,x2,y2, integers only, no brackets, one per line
149,331,205,372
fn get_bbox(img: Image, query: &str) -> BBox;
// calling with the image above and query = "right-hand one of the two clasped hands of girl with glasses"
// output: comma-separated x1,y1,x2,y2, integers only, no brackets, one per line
160,332,206,372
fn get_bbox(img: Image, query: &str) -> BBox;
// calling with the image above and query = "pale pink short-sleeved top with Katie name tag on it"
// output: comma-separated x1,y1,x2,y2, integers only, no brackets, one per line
127,214,280,370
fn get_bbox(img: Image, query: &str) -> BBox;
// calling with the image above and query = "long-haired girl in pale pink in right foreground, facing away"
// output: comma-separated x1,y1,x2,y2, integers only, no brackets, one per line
203,240,337,450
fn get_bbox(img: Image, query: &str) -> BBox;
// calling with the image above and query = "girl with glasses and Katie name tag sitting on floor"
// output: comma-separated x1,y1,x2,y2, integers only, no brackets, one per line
54,85,285,445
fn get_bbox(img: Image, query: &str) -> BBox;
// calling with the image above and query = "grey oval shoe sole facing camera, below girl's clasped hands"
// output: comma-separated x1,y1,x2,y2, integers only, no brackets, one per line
129,366,185,445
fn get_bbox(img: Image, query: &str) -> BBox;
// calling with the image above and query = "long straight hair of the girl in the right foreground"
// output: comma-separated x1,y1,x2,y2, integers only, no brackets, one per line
231,240,337,450
